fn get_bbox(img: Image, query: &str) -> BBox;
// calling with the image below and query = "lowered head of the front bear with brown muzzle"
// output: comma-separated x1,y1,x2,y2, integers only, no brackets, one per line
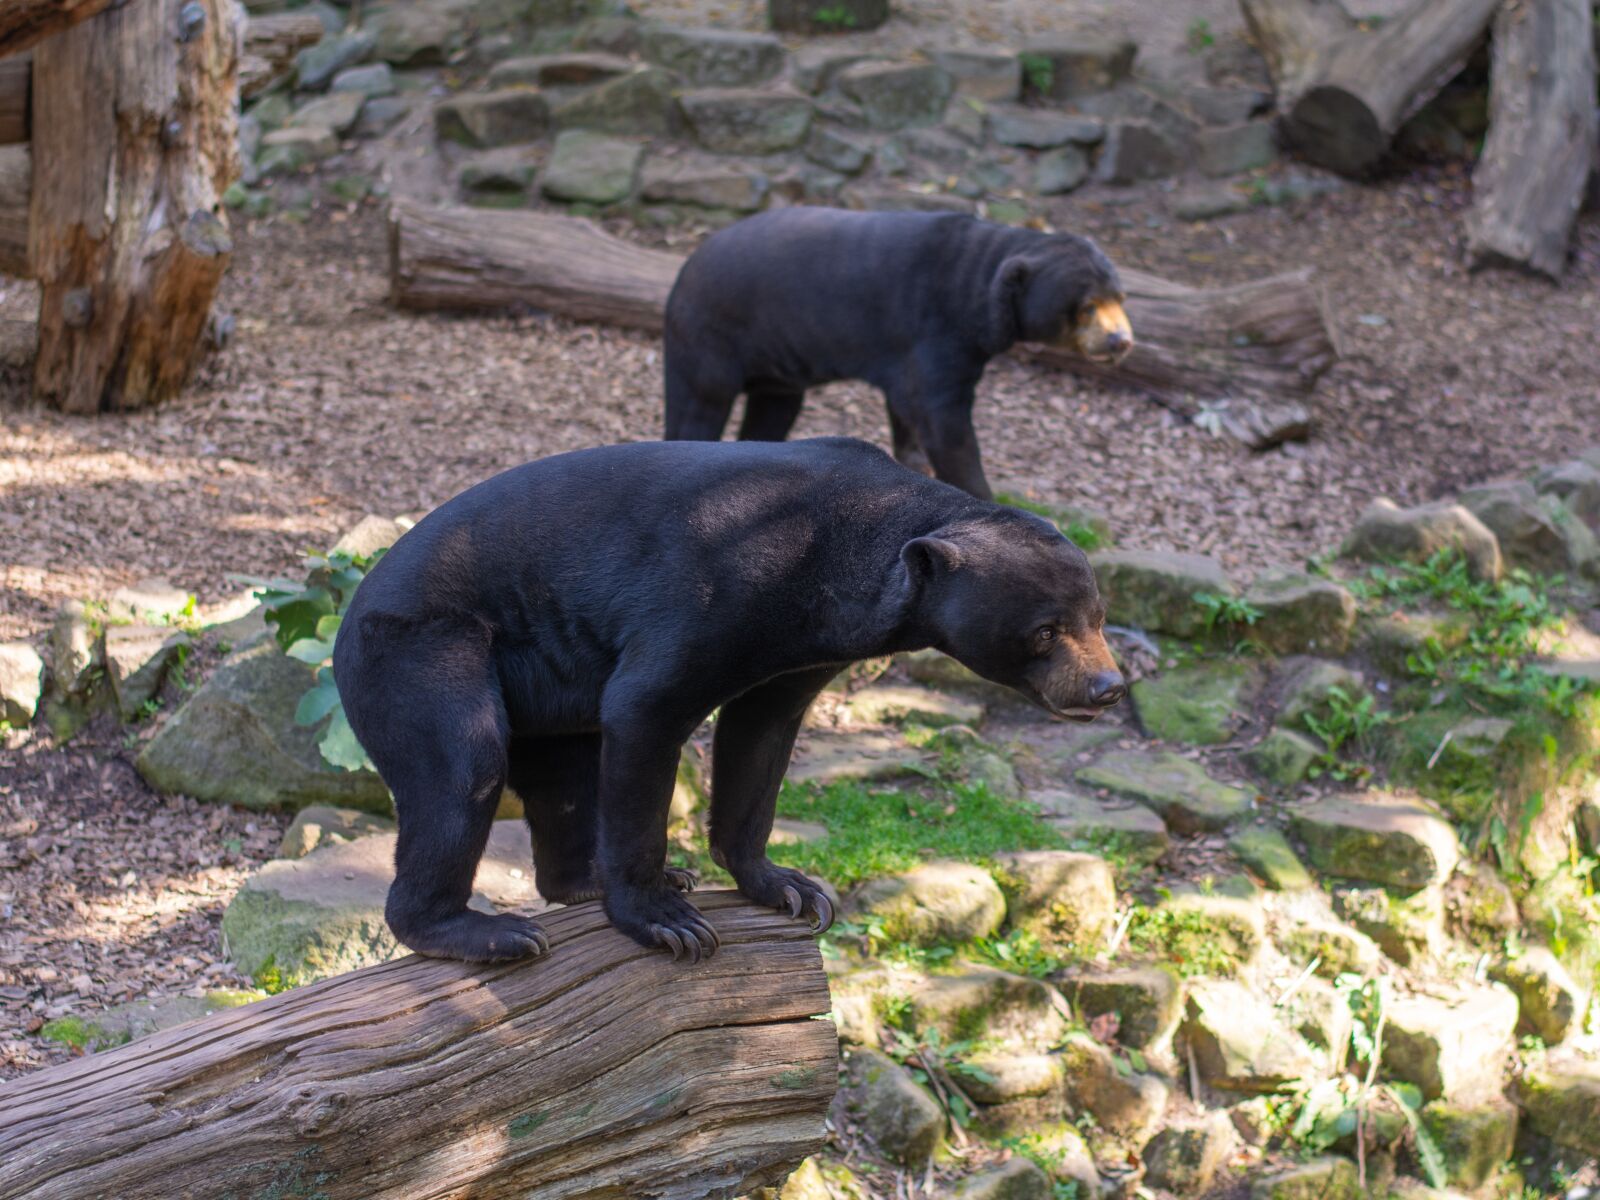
901,506,1128,722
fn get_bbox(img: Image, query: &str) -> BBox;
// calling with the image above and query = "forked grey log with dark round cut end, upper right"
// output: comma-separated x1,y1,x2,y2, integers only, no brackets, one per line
1242,0,1502,174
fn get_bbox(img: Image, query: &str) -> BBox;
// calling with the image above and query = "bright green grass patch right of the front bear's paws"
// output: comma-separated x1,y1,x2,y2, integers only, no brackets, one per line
770,782,1066,888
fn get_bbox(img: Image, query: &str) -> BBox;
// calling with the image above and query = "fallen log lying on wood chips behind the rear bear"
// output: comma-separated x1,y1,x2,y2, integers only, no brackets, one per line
389,202,1339,443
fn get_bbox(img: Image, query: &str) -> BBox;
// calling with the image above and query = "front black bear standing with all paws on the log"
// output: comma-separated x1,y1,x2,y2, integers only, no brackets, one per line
333,438,1125,960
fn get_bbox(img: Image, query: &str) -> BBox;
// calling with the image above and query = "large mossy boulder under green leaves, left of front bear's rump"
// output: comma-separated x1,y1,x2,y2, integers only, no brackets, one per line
138,637,389,813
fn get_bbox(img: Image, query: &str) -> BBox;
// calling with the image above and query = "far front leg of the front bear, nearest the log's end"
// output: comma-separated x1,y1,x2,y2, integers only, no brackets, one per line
710,667,838,933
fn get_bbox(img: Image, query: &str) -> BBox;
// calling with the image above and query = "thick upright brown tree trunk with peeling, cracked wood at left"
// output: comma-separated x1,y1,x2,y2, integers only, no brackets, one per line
29,0,238,413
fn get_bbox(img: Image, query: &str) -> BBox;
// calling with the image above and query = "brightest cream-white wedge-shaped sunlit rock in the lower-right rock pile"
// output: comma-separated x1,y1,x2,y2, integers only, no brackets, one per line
1179,979,1325,1093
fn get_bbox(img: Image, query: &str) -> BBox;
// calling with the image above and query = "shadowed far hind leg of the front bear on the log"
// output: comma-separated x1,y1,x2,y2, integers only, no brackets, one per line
506,733,698,904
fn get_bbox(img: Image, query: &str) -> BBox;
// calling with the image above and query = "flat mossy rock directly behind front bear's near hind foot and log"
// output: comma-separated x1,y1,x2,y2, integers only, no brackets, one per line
222,821,547,990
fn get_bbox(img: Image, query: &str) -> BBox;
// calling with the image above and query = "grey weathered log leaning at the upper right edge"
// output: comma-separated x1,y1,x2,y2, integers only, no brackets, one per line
1467,0,1600,278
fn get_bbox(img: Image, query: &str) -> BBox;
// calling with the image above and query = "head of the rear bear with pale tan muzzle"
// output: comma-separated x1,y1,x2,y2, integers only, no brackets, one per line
994,234,1133,363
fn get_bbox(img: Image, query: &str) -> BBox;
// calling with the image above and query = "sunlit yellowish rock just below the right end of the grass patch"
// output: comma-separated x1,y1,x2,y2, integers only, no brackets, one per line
994,850,1117,949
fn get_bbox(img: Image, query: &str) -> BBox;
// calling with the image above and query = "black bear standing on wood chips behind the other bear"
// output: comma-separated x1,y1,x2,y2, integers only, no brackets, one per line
666,208,1133,499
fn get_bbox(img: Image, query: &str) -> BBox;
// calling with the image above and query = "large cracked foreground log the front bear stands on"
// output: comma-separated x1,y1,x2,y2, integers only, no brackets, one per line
0,893,838,1200
